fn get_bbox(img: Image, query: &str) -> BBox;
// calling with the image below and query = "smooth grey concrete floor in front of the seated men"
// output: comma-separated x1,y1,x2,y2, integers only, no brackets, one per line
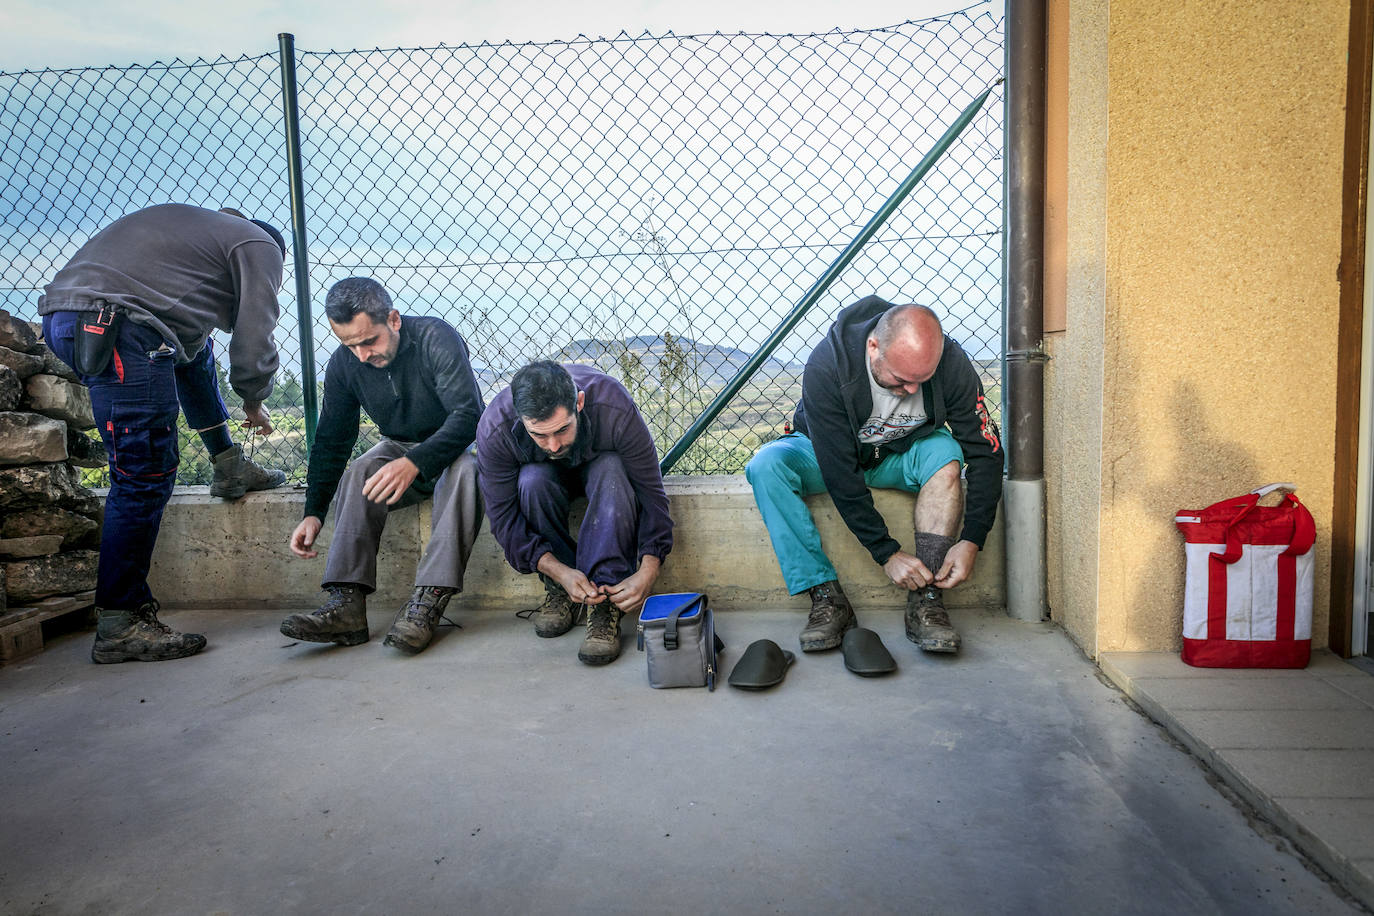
0,607,1364,915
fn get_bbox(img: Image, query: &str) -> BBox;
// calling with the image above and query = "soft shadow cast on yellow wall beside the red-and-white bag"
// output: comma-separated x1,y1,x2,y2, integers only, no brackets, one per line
1121,380,1272,652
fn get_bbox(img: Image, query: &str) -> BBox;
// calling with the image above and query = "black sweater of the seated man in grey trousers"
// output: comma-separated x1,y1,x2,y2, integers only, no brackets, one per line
305,314,482,520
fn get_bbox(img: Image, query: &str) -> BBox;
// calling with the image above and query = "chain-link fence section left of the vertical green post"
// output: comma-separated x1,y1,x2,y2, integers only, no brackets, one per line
0,55,305,485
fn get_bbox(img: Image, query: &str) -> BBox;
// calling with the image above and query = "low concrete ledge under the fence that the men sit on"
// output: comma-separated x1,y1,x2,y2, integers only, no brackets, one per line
148,475,1006,610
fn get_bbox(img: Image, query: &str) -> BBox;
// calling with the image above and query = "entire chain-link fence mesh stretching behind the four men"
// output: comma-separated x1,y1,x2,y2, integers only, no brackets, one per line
0,11,1003,483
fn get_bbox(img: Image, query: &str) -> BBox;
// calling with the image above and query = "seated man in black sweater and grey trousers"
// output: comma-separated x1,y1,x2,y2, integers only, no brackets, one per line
282,277,482,655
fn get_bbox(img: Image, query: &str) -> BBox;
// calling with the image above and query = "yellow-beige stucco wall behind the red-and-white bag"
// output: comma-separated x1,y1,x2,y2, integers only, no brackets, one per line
1047,0,1349,655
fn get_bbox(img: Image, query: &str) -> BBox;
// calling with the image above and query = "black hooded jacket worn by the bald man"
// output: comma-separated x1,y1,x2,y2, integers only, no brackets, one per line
793,295,1003,563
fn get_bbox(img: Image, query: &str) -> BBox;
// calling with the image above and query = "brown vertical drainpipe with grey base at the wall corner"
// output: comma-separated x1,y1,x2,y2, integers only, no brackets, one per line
1002,0,1048,621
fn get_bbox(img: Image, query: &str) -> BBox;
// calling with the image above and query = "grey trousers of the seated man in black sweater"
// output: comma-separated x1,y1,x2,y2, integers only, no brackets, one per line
323,439,482,592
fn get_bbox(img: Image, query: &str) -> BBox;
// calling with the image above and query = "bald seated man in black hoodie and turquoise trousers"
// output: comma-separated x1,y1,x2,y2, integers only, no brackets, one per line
745,297,1003,652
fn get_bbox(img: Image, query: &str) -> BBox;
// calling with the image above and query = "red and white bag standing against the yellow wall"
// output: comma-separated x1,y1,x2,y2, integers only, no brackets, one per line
1173,483,1316,667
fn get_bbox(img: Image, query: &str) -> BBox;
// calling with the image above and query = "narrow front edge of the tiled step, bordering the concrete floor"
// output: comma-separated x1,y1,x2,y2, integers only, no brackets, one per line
1098,652,1374,909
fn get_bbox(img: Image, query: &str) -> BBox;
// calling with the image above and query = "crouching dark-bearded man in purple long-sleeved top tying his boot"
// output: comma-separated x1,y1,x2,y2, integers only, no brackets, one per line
477,361,673,665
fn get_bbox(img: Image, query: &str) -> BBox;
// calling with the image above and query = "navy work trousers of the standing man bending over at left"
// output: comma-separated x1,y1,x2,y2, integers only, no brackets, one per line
43,312,229,610
